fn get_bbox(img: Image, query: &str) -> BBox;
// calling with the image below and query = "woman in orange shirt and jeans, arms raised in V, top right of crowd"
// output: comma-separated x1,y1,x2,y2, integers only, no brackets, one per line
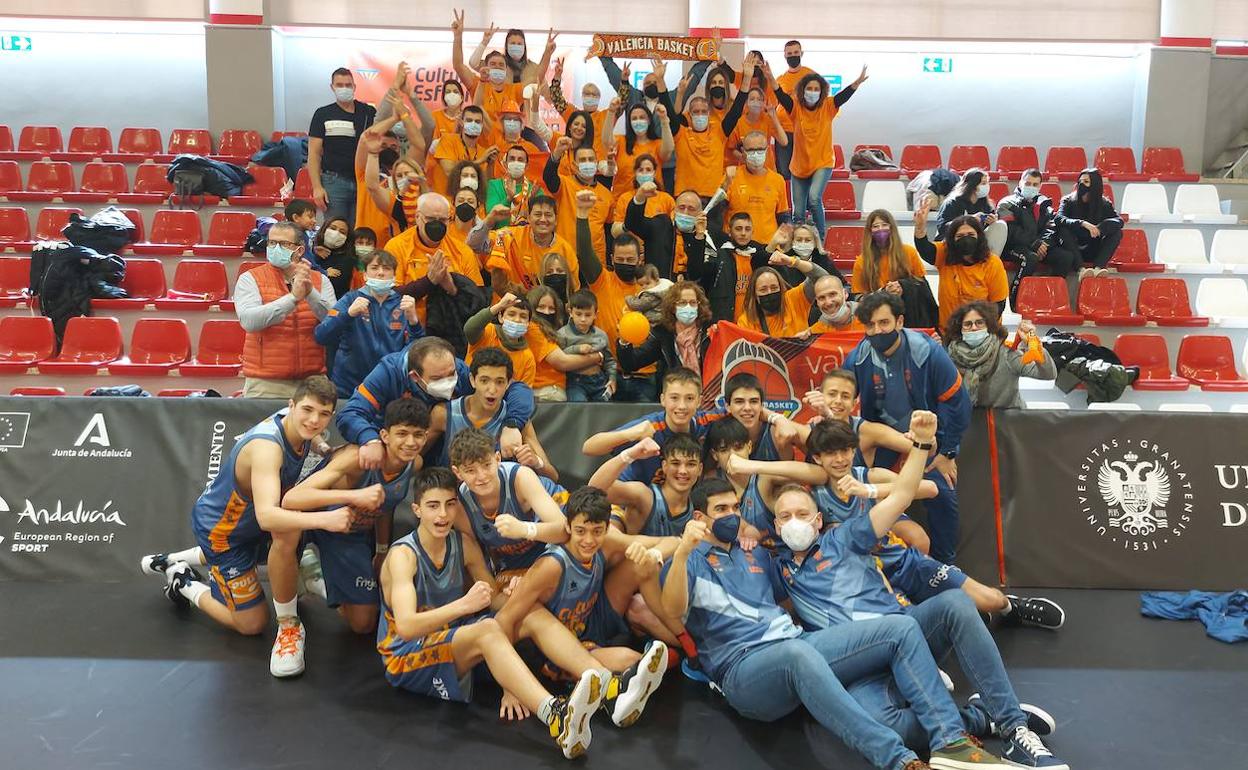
763,62,867,237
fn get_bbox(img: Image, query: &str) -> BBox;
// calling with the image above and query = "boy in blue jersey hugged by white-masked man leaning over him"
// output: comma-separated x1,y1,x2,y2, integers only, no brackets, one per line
429,347,559,482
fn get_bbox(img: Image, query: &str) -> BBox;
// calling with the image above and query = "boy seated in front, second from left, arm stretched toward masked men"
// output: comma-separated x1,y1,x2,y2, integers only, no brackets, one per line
498,487,675,728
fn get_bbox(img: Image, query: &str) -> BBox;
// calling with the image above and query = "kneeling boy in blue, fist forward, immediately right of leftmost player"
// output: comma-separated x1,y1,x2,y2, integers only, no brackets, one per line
282,398,429,634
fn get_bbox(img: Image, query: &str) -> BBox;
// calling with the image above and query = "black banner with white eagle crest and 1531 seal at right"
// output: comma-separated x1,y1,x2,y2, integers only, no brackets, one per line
993,411,1248,590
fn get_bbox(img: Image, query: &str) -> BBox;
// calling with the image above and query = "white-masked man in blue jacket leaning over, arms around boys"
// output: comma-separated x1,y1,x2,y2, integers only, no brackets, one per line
337,337,533,470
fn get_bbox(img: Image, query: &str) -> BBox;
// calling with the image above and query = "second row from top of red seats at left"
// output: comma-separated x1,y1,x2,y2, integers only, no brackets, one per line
0,161,288,206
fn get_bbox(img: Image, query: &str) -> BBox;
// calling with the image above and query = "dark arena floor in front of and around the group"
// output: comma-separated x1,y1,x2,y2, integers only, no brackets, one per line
0,579,1248,770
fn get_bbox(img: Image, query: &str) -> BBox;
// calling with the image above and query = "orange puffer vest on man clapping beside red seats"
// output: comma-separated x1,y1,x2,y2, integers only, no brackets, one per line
242,265,326,379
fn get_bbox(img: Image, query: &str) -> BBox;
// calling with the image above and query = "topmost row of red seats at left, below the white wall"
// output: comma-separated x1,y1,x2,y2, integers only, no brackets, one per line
0,126,307,162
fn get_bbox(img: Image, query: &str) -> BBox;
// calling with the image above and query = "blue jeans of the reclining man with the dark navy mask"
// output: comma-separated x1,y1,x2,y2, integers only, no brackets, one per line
721,615,962,769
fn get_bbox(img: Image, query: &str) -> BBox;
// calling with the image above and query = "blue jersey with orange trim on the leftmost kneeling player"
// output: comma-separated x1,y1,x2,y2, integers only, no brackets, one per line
191,409,308,553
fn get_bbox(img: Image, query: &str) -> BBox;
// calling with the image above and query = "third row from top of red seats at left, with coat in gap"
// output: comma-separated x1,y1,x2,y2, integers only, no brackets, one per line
0,206,263,257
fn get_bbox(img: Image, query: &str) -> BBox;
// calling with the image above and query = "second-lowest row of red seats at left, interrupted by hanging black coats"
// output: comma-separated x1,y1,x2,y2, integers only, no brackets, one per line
0,257,263,312
